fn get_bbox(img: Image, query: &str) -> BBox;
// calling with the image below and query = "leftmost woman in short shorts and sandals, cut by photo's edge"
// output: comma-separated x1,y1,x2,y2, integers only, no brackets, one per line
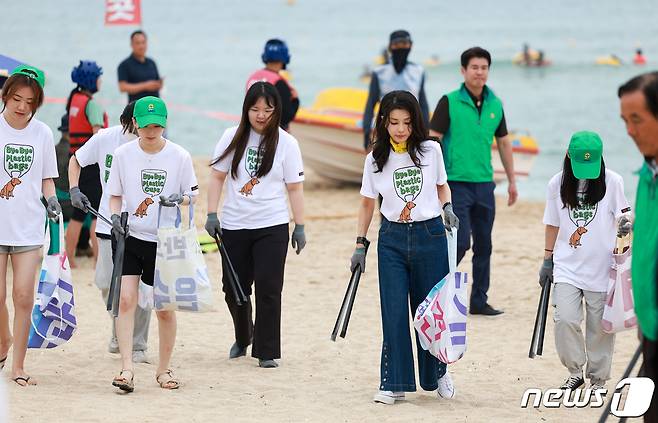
0,65,62,386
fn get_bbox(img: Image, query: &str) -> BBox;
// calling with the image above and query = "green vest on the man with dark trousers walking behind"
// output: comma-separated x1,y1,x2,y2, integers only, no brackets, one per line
443,84,503,182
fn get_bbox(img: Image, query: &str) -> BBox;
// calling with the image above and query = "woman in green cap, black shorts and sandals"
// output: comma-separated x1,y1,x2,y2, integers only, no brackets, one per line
107,96,198,392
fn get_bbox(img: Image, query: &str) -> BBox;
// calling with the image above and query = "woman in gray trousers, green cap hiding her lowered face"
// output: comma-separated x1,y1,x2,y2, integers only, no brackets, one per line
539,131,630,390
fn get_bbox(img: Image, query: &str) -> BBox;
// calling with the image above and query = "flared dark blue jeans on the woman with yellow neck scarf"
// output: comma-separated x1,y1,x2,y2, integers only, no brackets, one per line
377,217,448,392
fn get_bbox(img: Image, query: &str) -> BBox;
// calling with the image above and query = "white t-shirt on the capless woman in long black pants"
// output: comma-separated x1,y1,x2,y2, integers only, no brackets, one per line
213,126,304,230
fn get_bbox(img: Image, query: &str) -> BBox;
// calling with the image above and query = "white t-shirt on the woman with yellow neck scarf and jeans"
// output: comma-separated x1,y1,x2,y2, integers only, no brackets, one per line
361,141,448,223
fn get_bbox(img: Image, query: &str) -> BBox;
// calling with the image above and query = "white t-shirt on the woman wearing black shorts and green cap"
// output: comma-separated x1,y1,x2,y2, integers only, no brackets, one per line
107,138,199,242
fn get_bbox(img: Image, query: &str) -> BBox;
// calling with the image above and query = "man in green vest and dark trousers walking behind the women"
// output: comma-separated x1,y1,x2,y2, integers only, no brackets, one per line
430,47,518,316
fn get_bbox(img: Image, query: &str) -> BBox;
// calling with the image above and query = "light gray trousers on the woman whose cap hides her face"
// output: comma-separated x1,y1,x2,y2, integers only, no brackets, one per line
553,282,615,384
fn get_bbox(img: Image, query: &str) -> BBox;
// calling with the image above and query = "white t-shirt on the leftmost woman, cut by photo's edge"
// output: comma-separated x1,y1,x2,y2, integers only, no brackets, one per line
0,114,59,246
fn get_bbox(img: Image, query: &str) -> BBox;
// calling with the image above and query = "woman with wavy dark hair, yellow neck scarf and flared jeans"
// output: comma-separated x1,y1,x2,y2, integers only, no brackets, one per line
350,91,459,404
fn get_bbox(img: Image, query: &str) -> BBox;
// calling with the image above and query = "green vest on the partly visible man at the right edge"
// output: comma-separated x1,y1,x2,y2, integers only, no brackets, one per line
631,163,658,342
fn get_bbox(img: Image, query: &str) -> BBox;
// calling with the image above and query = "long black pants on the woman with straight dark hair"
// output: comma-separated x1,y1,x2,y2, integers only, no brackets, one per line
222,223,288,360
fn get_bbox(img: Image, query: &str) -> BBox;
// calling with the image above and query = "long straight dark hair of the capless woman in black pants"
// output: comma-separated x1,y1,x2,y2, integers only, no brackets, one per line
210,82,281,179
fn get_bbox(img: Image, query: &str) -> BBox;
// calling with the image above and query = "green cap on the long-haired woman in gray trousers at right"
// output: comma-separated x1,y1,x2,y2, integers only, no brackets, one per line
569,131,603,179
